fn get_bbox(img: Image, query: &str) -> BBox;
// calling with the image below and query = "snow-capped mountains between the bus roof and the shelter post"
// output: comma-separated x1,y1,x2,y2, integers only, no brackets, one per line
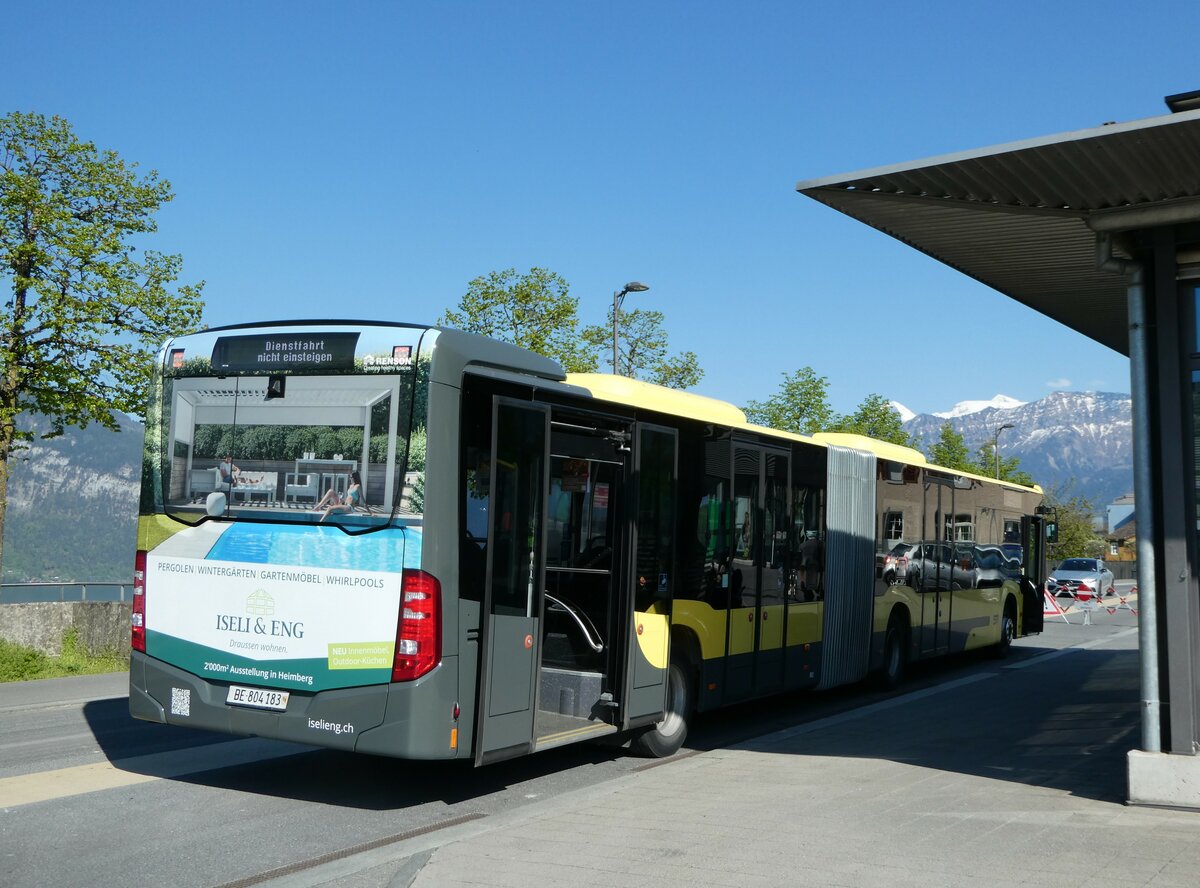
901,391,1133,510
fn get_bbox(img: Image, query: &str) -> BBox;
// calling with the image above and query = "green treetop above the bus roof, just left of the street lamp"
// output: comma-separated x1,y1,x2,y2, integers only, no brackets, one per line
438,266,598,373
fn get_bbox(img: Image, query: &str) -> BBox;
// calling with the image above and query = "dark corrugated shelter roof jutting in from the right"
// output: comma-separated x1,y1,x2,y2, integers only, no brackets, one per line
796,103,1200,355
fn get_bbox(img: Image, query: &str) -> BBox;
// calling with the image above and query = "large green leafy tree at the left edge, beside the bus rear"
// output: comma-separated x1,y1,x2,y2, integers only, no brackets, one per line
0,112,204,571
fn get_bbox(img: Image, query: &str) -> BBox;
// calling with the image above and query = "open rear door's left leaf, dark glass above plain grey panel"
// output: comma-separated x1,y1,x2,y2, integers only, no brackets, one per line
475,398,548,764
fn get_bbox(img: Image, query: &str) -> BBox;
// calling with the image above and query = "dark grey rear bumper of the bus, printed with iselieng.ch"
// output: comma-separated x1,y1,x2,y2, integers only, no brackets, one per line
130,652,458,758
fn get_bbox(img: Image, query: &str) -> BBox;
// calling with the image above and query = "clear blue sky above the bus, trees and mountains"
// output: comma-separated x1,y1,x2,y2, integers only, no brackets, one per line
0,0,1200,412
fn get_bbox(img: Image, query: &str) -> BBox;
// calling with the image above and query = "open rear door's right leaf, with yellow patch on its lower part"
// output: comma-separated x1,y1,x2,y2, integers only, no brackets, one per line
625,424,678,725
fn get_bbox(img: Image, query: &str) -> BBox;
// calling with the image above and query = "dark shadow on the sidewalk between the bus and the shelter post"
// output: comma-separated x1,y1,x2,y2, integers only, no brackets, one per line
697,647,1141,803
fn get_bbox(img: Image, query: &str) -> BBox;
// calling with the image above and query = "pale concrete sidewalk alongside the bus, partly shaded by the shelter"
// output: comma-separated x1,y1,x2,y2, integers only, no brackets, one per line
277,612,1200,888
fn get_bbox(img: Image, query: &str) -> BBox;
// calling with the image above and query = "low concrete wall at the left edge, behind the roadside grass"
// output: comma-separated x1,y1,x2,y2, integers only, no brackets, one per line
0,601,130,656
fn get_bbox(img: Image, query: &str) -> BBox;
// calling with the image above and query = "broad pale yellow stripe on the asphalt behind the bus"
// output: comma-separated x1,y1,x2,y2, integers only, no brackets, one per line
0,738,312,808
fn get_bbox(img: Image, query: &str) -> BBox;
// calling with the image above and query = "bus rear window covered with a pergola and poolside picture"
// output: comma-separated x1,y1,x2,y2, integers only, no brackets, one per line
156,371,425,527
